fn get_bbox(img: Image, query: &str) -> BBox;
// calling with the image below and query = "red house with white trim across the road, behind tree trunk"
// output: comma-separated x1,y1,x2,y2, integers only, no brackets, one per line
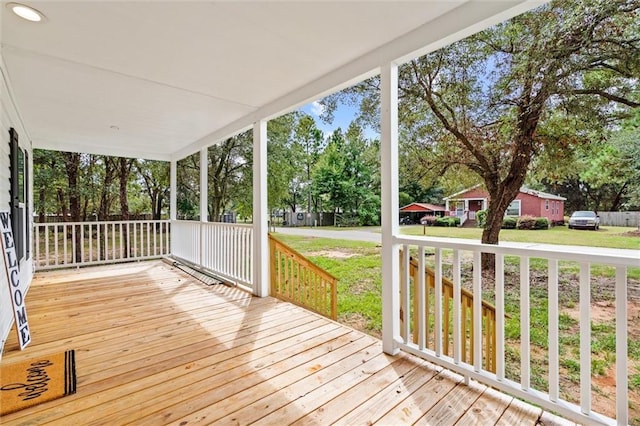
444,184,566,223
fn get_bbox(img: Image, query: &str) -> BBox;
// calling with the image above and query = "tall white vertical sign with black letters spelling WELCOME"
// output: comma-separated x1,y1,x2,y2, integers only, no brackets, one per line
0,211,31,350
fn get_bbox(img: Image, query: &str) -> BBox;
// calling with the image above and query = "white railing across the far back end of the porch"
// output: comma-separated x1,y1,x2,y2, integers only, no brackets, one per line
34,220,170,270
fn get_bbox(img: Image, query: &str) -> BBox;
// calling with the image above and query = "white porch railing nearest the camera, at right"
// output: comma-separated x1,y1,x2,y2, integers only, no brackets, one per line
393,236,640,425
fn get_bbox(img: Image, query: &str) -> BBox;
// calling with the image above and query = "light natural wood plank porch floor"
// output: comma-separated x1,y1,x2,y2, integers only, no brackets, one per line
1,261,562,425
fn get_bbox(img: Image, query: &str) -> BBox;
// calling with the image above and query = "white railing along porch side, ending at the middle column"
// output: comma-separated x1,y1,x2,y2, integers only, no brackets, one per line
171,220,253,287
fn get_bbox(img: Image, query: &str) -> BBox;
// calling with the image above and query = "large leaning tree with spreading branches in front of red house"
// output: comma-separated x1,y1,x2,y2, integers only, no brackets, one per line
324,0,640,267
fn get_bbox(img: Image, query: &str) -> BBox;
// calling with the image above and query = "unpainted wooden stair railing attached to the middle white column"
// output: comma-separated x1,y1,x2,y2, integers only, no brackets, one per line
269,235,338,320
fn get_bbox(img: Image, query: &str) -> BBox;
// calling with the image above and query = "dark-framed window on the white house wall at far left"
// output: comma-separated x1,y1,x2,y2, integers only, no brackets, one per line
9,128,30,260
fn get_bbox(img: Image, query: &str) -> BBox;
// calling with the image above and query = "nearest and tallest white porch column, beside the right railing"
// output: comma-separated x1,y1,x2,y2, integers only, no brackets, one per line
380,59,400,355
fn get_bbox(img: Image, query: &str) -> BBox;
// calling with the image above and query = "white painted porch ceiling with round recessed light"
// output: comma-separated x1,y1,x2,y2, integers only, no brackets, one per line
1,0,542,160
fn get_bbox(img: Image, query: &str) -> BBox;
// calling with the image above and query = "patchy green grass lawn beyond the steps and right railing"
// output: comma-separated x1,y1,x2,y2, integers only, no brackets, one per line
276,225,640,425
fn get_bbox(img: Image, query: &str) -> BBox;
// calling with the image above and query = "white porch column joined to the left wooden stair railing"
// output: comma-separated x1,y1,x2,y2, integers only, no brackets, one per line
253,120,270,297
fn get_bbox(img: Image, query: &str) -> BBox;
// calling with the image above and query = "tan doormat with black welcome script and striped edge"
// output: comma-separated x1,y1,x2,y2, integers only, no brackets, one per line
0,350,76,415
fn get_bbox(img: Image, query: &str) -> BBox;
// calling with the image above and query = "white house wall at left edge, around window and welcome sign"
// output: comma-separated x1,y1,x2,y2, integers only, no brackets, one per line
0,51,33,358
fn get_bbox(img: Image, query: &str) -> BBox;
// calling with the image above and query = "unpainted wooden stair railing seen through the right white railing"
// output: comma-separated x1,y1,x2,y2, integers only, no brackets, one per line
400,252,496,373
